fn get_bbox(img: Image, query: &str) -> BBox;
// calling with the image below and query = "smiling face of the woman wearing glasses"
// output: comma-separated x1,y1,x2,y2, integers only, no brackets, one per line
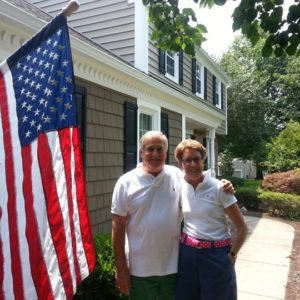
181,148,204,183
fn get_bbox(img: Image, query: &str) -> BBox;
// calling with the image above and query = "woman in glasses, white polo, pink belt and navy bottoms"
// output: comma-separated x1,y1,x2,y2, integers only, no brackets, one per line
174,139,247,300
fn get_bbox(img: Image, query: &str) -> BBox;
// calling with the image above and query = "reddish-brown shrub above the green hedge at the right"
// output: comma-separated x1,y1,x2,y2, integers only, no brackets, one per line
262,169,300,195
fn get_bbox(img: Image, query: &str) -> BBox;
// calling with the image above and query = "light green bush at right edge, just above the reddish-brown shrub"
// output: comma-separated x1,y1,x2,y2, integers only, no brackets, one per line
265,121,300,172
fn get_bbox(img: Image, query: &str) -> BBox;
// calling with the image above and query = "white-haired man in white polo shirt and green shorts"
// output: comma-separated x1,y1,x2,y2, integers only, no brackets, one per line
111,131,233,300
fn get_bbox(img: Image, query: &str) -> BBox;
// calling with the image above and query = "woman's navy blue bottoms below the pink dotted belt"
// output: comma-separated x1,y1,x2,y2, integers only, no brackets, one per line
176,244,237,300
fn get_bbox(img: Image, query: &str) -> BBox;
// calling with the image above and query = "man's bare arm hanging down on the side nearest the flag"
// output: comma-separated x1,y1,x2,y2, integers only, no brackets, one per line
112,215,130,295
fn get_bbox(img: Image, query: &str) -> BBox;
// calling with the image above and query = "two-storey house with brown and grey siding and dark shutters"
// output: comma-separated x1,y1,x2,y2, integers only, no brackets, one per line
0,0,228,233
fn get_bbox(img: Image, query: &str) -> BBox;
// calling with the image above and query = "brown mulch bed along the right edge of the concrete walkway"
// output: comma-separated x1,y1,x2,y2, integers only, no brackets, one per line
245,211,300,300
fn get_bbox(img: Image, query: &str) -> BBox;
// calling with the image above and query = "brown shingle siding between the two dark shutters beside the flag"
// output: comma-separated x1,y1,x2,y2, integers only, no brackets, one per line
76,78,136,233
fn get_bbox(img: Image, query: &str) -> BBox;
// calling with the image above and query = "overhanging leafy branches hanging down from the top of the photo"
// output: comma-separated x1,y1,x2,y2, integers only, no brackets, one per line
143,0,300,57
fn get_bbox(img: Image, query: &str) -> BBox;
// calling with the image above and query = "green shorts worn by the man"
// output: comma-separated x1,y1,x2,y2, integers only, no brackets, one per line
129,274,177,300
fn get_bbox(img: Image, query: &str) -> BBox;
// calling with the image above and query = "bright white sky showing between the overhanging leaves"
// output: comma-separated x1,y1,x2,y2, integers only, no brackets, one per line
179,0,294,57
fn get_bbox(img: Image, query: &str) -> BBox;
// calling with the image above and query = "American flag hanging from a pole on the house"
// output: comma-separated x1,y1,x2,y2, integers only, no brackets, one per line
0,14,95,300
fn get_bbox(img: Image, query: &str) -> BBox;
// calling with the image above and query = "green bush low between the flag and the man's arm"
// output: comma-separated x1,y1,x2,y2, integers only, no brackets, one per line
74,234,127,300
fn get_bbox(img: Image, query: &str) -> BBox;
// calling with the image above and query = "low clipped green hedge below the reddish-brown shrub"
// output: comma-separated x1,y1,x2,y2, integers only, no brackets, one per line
258,191,300,220
